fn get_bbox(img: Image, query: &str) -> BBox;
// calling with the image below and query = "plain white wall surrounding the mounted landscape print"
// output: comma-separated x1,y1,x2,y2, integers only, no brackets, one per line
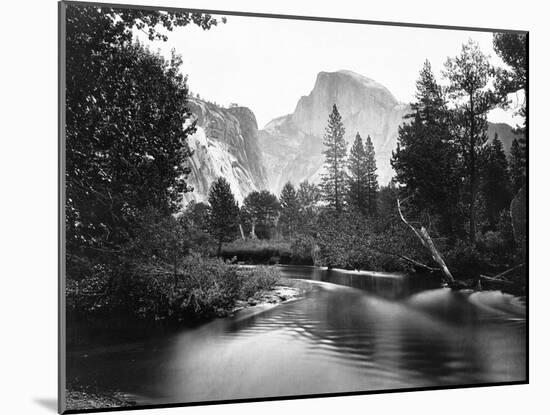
0,0,550,415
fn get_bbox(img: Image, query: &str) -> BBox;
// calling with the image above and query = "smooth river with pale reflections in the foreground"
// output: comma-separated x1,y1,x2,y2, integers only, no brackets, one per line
68,266,526,404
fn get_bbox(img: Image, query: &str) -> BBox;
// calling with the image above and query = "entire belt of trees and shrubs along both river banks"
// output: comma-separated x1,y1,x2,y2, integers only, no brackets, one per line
65,6,528,330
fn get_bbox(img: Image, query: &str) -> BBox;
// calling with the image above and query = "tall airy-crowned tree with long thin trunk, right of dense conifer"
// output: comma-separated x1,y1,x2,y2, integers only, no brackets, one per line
445,40,497,244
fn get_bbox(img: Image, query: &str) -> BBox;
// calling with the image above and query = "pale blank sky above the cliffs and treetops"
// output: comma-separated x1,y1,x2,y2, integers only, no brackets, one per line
138,16,519,128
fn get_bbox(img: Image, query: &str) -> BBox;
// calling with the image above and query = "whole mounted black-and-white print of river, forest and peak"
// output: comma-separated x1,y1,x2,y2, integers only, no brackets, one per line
59,1,528,413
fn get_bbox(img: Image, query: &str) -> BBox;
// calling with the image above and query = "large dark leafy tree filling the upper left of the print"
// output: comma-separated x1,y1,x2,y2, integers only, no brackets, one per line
65,5,224,262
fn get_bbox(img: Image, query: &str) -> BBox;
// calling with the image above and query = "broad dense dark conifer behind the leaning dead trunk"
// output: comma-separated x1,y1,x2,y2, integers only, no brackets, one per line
391,61,459,235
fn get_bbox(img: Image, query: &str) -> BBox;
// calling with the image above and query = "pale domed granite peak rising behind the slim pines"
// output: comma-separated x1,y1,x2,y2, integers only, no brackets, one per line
260,71,409,193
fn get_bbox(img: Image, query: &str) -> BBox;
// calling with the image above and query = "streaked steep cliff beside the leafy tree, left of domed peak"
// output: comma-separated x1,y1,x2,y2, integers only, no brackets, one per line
183,98,267,204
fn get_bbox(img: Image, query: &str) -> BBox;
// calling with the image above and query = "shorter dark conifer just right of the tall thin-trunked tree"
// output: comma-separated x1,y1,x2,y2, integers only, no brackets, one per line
480,133,511,229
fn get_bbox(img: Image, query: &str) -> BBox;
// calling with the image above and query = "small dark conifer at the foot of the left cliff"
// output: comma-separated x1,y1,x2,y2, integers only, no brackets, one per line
208,177,239,256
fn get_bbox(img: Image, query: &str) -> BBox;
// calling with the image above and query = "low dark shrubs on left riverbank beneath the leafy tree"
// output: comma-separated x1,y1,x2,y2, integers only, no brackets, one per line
67,255,280,327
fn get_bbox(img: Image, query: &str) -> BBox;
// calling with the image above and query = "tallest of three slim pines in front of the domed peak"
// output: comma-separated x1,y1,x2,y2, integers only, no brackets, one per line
321,104,346,212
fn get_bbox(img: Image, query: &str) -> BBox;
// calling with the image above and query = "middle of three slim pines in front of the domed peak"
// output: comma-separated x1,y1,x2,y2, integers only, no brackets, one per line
347,132,367,214
